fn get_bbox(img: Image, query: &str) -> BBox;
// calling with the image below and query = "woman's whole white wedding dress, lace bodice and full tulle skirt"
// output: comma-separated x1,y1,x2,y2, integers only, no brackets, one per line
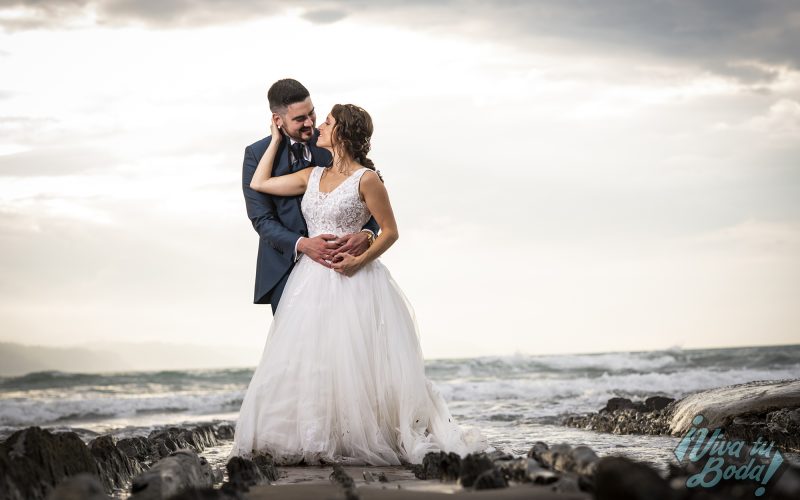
228,167,488,465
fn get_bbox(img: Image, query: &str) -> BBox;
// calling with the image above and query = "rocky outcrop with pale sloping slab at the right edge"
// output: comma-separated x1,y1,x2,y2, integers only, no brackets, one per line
562,380,800,452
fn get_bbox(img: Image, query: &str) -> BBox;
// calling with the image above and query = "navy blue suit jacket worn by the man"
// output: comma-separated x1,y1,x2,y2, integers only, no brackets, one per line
242,130,378,304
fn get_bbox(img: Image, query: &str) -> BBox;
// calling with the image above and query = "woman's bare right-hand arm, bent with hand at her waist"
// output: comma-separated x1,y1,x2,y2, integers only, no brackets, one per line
331,171,400,276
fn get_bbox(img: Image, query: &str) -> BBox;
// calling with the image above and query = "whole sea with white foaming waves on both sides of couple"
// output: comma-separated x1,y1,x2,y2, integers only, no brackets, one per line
0,345,800,470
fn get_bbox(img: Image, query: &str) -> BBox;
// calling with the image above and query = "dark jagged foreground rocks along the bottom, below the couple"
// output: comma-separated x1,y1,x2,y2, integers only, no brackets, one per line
0,422,800,500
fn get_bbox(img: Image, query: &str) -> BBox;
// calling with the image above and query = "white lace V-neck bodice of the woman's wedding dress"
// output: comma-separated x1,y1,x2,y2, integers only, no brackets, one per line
300,167,371,238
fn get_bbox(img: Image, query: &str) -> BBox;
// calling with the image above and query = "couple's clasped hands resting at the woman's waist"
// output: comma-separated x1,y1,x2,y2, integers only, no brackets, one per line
297,232,369,276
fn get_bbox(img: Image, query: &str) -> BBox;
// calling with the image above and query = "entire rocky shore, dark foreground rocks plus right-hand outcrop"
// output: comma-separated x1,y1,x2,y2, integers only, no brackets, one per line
0,381,800,500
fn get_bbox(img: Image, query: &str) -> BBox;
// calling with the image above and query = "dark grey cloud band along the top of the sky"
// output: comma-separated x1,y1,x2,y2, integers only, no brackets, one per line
0,0,800,83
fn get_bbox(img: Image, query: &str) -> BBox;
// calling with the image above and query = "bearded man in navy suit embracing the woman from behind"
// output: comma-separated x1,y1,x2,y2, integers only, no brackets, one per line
242,78,378,314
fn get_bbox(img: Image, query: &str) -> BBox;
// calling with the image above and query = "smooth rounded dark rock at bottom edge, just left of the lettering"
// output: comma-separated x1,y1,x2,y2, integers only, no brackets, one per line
594,457,672,500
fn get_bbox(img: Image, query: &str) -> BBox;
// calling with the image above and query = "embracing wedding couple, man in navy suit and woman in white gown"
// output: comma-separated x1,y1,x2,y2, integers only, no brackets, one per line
228,79,488,465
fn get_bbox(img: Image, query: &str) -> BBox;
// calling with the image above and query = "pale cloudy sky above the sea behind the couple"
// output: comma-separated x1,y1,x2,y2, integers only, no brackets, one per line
0,0,800,364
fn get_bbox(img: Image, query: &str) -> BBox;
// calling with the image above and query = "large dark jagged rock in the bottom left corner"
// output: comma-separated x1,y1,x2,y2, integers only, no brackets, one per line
0,426,103,500
